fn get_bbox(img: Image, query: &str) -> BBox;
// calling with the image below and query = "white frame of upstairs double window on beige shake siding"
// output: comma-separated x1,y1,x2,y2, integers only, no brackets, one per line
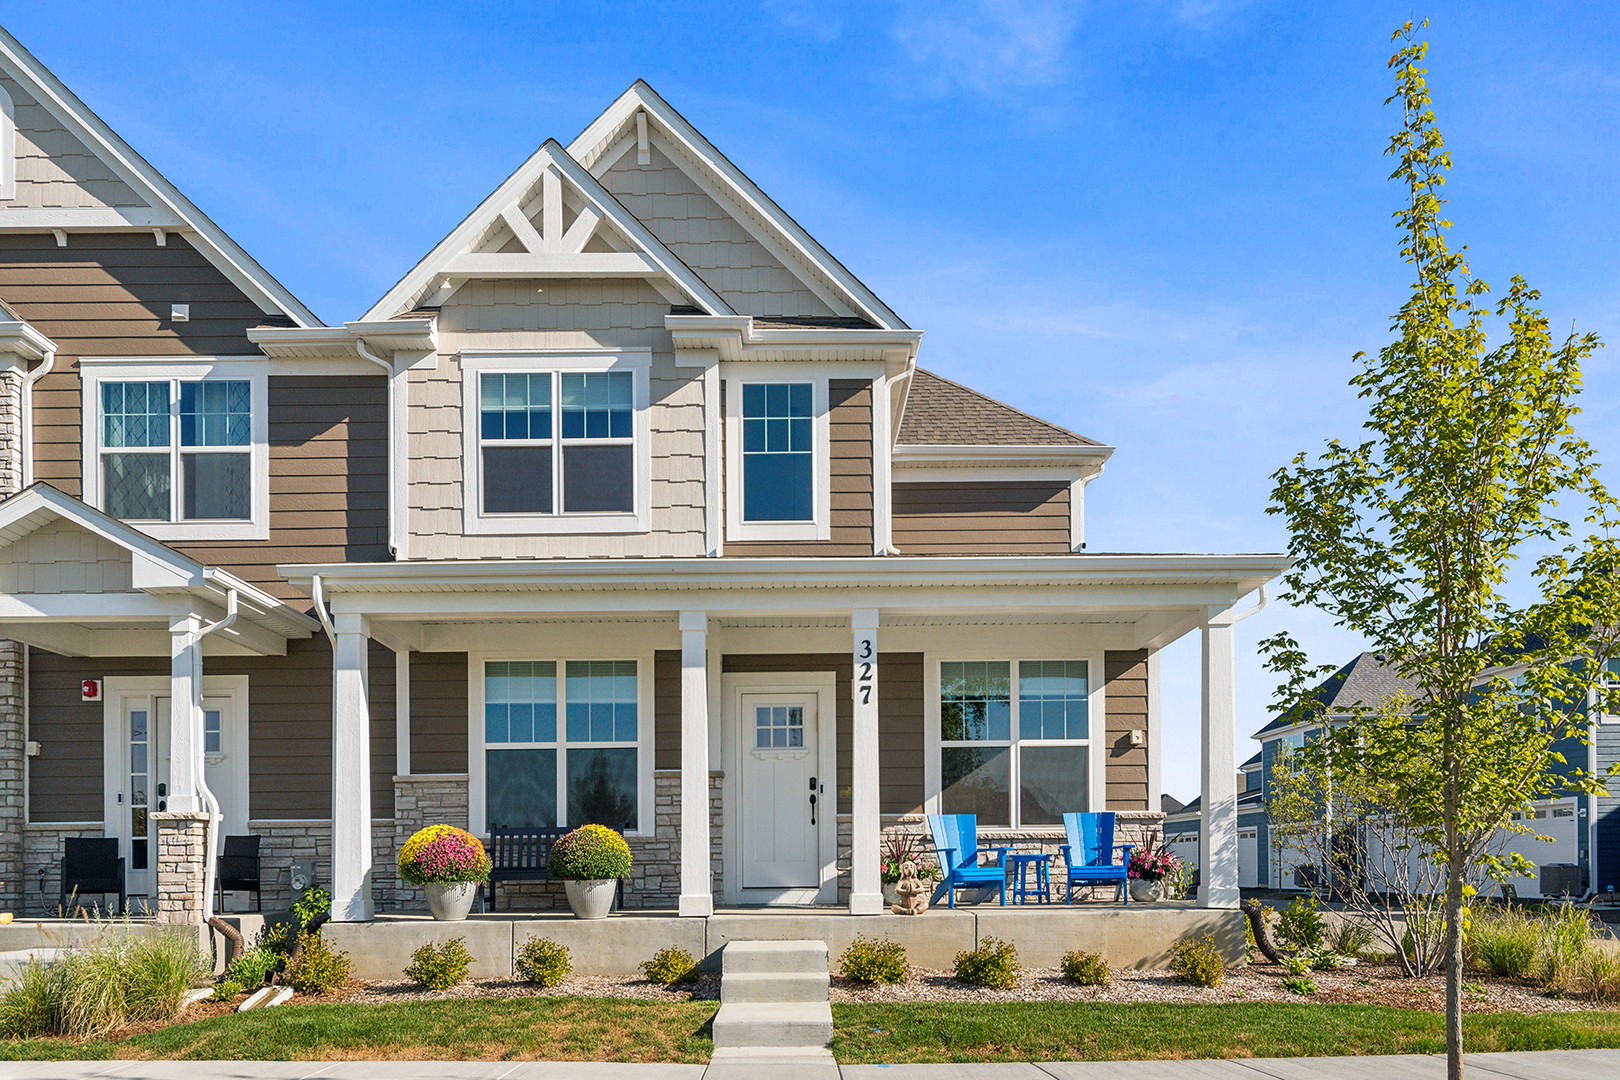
462,348,653,536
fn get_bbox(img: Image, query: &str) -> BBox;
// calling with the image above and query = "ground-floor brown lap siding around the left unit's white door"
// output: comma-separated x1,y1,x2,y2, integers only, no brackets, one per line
29,636,396,821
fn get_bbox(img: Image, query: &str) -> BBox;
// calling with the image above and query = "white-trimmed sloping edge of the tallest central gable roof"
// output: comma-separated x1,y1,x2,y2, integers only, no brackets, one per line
569,79,909,330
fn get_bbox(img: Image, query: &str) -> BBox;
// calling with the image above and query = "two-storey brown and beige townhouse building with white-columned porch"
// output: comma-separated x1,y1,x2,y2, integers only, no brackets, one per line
0,25,1286,920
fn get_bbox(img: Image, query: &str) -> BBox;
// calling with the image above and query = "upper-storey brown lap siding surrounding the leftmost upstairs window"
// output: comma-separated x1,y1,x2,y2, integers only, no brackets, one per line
0,233,389,607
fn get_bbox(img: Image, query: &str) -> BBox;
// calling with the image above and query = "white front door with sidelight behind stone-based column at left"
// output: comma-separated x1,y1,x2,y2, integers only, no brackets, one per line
104,675,248,899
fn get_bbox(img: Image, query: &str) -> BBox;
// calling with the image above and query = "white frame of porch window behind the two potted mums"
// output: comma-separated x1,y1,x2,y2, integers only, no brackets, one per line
467,649,656,837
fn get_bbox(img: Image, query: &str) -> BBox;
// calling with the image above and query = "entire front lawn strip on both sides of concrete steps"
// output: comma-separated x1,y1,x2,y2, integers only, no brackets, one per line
0,997,1620,1064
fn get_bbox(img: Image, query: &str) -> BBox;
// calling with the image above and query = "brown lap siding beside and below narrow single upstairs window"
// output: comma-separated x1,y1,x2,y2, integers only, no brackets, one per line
721,379,873,559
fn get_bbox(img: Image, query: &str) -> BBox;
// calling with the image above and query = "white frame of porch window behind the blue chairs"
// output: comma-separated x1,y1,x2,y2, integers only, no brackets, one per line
923,654,1108,832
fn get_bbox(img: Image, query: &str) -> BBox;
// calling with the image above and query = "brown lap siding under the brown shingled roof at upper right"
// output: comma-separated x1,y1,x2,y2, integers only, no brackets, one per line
894,481,1069,555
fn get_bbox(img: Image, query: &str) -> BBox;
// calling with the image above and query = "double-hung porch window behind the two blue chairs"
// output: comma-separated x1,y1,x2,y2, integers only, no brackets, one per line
940,661,1092,827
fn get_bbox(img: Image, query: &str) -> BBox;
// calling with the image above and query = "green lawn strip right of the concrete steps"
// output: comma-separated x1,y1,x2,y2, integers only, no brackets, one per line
833,1002,1620,1064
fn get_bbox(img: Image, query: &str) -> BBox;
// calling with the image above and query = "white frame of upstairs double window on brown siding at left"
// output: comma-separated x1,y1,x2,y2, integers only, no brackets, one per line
79,356,271,541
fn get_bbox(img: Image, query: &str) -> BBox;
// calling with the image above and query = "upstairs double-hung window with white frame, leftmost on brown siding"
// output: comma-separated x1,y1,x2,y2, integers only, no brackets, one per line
81,359,269,539
